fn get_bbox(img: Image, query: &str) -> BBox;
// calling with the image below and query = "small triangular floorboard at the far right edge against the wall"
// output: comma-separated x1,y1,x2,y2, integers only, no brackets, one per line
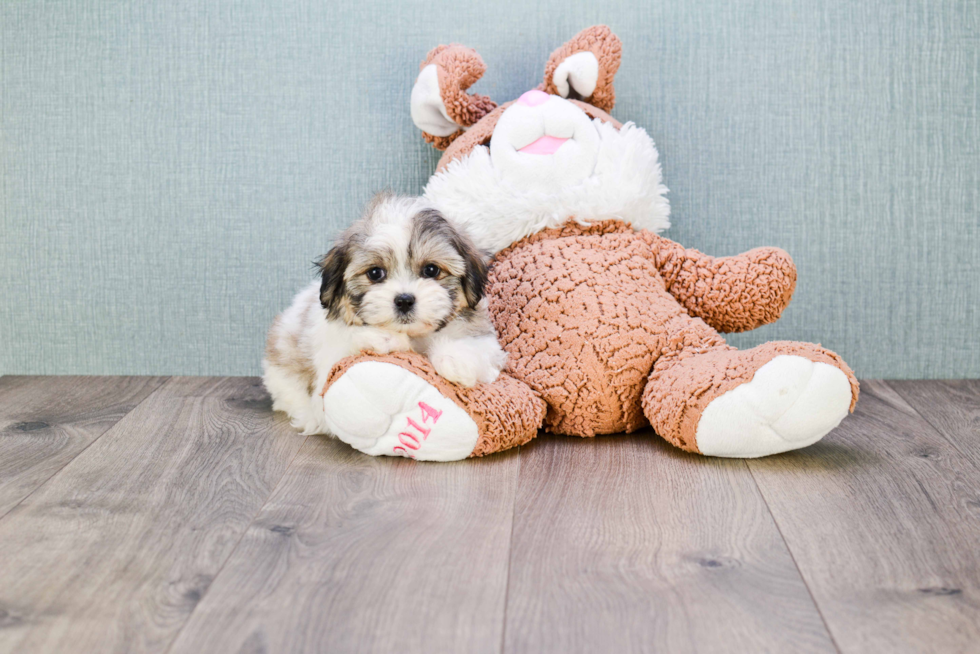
888,379,980,466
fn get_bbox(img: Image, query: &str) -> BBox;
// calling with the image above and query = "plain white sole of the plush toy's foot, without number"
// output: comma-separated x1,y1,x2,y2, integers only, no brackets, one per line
697,355,851,458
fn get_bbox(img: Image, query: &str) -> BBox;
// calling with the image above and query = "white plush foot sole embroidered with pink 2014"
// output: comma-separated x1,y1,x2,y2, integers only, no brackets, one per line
323,361,479,461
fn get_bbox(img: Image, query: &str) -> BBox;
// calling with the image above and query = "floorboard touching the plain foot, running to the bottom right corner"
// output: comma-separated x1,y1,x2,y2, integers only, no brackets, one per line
749,381,980,652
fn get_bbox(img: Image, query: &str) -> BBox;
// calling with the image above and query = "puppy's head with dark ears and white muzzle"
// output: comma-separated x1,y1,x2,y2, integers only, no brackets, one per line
320,195,487,336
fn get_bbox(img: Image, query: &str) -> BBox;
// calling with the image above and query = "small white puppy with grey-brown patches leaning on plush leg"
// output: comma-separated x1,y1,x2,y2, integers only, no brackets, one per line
262,194,507,434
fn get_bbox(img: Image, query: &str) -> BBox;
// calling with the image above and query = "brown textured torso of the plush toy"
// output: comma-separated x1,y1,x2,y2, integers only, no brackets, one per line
487,230,683,436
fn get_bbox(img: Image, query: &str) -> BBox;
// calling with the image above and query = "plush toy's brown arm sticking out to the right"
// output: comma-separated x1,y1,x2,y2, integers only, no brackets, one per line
645,232,796,333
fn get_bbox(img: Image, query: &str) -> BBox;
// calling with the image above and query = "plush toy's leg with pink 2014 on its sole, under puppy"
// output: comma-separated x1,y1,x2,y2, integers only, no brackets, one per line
320,353,545,461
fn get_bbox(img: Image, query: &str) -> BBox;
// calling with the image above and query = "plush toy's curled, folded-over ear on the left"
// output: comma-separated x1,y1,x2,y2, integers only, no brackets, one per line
412,45,497,150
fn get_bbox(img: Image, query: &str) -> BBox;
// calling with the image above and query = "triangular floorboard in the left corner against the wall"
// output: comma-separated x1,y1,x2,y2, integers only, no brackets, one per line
0,376,166,517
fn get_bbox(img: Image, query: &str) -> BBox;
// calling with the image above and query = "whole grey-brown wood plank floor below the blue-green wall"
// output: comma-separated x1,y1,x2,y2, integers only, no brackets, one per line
0,377,980,654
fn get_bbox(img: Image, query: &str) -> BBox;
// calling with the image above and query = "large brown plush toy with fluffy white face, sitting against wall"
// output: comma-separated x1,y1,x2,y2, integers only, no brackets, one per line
320,26,858,461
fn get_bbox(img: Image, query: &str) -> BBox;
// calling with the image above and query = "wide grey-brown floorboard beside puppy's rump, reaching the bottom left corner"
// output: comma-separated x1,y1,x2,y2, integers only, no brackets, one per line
0,378,304,653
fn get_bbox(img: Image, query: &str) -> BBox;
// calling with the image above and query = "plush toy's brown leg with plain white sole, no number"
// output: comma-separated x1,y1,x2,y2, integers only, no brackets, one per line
643,320,858,458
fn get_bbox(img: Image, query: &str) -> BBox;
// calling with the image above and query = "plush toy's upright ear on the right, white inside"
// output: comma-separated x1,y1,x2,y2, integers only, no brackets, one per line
540,25,622,112
